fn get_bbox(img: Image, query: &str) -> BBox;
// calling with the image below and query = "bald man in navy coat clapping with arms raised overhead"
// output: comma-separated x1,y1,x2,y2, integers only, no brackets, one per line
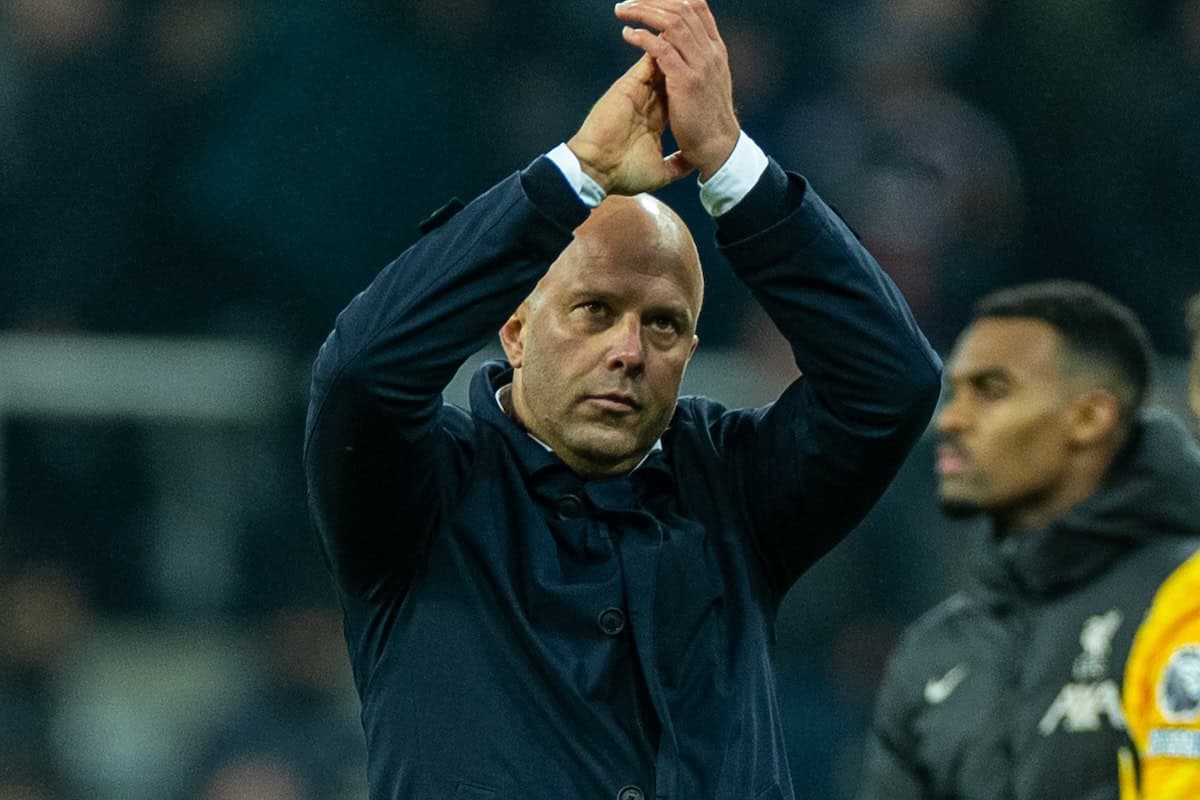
305,0,941,800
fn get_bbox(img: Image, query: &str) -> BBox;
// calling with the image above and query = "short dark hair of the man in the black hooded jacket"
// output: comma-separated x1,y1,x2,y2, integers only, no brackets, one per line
976,281,1152,421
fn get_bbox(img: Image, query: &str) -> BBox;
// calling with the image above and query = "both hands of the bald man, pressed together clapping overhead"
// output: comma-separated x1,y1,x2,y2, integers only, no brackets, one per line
566,0,740,194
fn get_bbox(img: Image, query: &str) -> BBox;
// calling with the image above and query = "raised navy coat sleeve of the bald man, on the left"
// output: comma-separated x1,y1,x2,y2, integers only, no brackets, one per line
304,158,587,594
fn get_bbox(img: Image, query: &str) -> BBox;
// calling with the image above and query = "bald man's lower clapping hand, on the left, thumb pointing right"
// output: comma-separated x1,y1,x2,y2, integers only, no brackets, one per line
566,55,694,194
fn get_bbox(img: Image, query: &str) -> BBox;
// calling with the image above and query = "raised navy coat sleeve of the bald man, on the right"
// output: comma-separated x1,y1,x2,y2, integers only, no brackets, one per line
718,162,941,595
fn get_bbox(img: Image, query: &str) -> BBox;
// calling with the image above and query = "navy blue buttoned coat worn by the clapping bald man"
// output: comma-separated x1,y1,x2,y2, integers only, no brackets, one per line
305,158,941,800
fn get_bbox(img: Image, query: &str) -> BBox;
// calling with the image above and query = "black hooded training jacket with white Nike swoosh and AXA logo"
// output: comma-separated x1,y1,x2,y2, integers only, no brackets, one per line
858,411,1200,800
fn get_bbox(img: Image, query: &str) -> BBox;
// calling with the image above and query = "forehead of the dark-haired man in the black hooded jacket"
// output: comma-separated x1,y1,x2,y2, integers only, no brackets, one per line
948,317,1061,378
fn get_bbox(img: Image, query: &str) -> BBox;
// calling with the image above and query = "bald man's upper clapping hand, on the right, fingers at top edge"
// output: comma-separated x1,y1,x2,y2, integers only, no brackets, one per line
616,0,740,180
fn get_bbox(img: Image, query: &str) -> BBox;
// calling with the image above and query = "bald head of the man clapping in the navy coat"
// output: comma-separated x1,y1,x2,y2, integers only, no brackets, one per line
500,194,704,477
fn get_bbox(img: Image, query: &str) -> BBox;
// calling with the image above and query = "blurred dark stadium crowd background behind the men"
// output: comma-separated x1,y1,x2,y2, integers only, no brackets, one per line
0,0,1200,800
